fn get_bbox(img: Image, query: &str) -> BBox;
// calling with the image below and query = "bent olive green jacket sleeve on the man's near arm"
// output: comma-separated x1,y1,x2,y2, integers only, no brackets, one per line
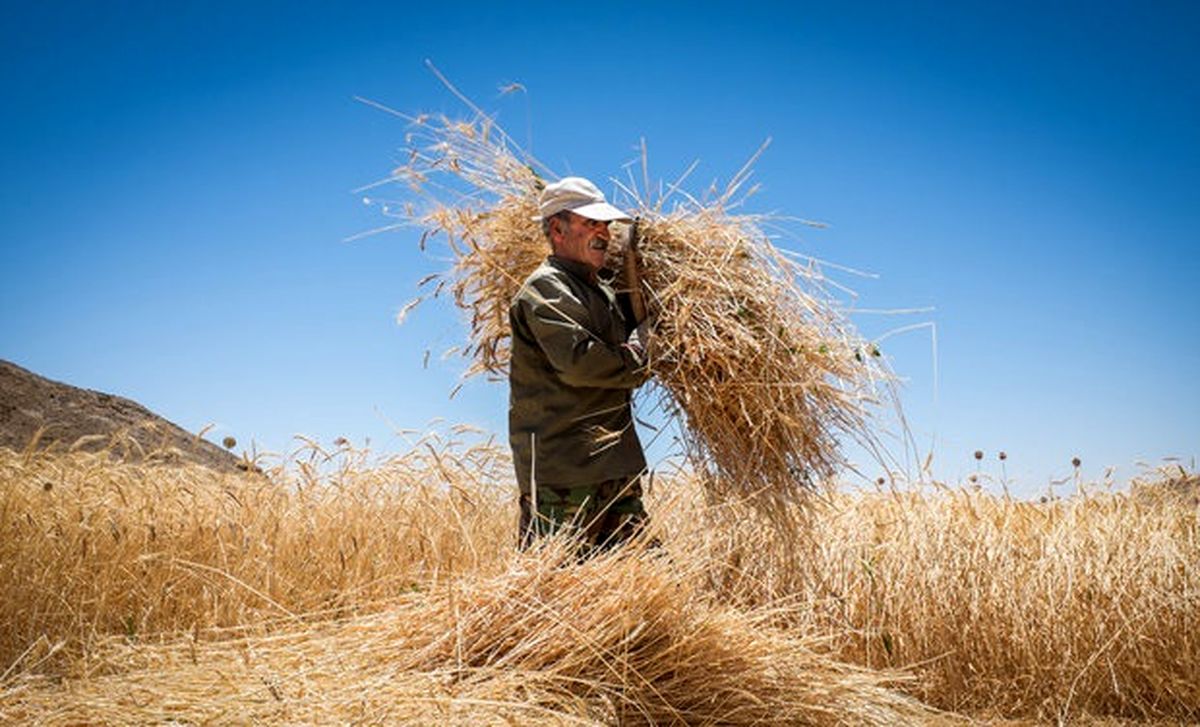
518,277,649,389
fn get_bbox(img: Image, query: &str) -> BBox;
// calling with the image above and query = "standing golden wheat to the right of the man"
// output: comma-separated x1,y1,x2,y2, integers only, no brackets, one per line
667,488,1200,719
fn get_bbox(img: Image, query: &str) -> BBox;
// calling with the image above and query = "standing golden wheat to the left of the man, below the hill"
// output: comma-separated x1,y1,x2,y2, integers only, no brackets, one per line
0,429,510,673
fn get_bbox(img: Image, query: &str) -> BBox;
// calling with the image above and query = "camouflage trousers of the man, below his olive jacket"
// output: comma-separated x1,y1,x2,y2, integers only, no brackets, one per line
520,476,646,554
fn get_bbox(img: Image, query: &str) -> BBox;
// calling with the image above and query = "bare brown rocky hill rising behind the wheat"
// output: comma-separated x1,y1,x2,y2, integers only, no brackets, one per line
0,360,246,471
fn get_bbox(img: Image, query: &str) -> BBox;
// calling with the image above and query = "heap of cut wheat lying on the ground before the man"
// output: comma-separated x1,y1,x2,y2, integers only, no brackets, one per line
0,542,937,725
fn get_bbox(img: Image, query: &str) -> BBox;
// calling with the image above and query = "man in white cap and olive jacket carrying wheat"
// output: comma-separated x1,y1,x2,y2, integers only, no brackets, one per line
509,176,649,552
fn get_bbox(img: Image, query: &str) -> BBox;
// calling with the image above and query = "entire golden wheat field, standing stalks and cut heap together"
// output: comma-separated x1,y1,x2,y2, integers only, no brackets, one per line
0,441,1200,723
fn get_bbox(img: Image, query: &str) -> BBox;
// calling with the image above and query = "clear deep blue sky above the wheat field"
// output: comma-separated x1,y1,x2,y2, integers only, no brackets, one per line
0,0,1200,493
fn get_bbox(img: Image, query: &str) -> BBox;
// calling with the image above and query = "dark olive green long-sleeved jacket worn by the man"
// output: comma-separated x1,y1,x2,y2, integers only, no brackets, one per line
509,256,649,492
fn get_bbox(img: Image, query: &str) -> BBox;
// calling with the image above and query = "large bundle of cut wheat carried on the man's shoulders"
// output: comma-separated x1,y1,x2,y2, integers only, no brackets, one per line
364,102,890,500
